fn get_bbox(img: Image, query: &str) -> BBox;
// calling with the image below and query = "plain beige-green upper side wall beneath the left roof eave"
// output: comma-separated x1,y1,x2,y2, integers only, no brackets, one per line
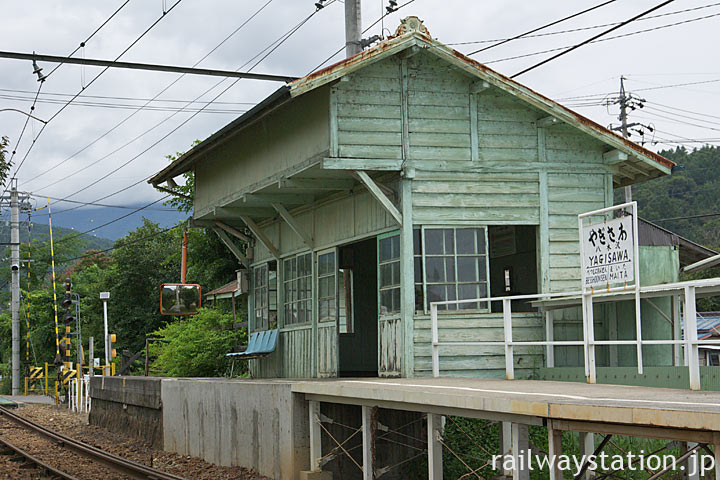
195,88,330,217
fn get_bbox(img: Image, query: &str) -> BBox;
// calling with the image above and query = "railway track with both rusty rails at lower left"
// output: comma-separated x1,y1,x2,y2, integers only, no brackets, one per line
0,407,184,480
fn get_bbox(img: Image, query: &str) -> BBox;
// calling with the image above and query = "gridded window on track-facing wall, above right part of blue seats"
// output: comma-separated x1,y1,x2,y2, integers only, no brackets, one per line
283,253,312,325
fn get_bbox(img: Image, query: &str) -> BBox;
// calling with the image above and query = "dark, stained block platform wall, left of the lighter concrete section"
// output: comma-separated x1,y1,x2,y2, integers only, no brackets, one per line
89,377,163,448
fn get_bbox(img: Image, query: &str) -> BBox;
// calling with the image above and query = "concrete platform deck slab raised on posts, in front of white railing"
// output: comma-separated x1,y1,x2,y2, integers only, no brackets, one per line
292,378,720,443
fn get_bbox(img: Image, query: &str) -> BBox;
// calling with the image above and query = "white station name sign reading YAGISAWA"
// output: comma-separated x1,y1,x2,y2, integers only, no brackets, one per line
581,216,635,289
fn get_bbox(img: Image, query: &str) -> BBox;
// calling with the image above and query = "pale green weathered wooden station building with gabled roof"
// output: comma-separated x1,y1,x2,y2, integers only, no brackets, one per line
150,17,680,378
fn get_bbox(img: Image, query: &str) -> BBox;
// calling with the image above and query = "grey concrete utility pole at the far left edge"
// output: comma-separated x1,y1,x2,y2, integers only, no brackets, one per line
10,178,20,395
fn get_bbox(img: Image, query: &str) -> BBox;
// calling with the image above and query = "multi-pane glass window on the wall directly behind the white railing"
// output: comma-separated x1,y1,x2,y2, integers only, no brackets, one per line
415,227,488,310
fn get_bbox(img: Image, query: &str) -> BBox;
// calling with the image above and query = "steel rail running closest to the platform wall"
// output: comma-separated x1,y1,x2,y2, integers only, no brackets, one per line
0,407,184,480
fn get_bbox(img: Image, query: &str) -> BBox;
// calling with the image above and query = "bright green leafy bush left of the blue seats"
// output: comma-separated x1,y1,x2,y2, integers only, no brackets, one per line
152,308,243,377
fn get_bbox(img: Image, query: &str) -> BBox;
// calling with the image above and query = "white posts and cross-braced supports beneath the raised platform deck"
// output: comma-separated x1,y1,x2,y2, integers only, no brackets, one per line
305,394,720,480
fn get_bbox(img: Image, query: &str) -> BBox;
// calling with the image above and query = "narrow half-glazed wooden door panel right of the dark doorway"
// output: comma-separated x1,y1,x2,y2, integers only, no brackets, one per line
378,232,403,377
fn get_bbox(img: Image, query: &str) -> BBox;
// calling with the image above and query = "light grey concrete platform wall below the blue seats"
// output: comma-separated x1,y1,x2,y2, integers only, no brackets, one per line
161,378,310,480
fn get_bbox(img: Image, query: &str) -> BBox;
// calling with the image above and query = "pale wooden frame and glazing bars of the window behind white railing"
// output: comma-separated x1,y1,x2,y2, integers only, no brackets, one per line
420,224,491,315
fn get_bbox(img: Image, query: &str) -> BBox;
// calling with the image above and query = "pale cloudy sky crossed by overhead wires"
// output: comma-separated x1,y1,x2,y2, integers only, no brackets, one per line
0,0,720,224
